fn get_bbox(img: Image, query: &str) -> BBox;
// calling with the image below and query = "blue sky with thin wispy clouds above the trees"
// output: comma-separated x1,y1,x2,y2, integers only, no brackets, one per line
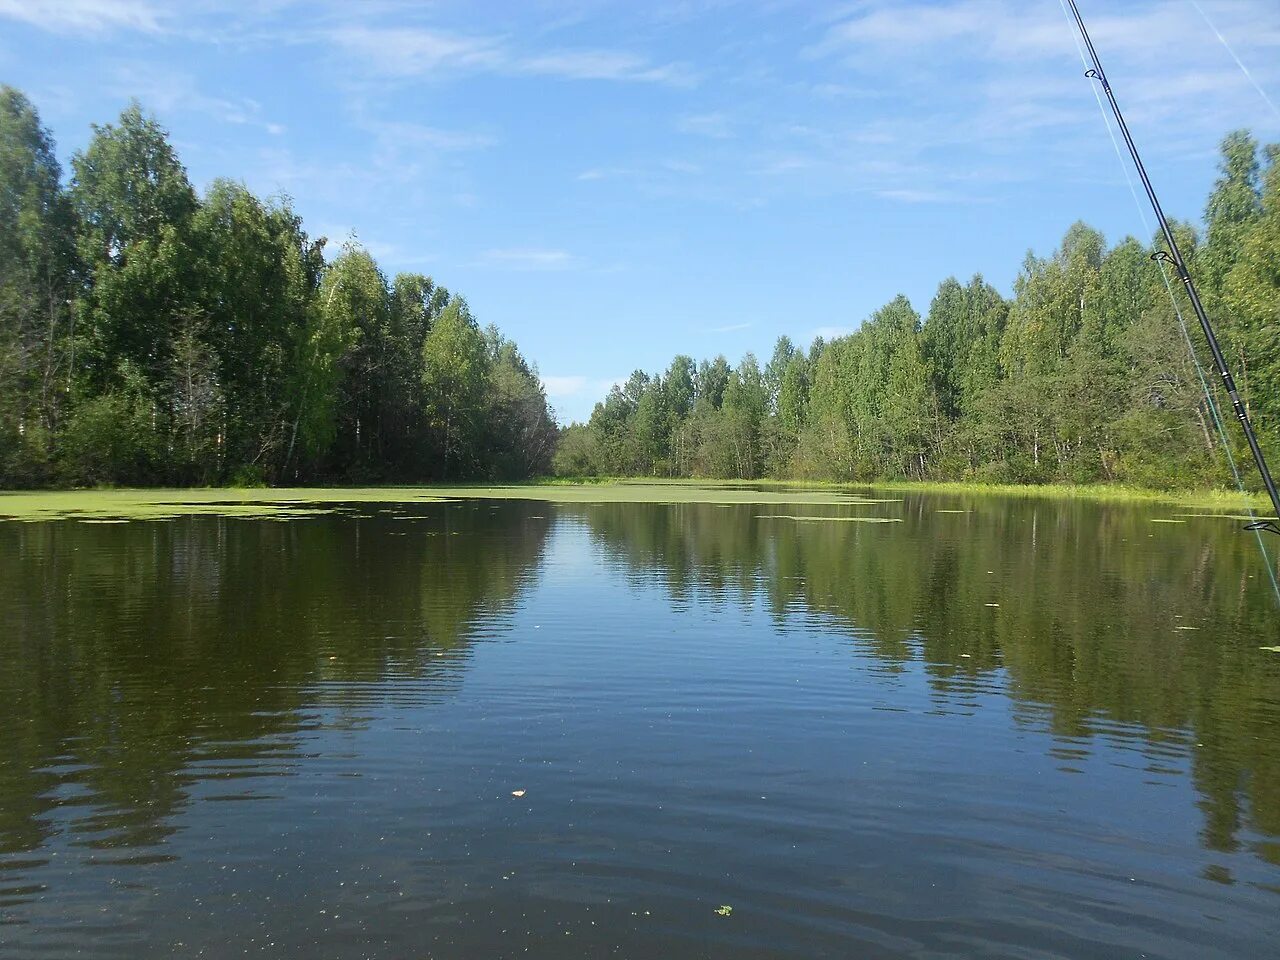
0,0,1280,421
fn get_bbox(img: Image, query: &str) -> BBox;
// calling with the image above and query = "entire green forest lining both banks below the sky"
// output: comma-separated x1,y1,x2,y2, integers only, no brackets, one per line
0,79,1280,488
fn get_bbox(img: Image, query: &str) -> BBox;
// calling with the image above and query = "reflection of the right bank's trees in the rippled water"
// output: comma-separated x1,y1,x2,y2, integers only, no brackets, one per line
582,498,1280,861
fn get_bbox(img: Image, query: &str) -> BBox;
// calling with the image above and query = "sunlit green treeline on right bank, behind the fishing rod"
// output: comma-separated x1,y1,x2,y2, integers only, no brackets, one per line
556,132,1280,486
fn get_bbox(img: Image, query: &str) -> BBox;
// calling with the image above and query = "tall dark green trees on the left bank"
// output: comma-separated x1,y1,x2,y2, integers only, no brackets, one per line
0,87,556,486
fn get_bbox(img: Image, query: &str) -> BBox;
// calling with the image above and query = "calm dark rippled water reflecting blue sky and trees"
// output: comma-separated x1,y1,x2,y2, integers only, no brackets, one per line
0,497,1280,960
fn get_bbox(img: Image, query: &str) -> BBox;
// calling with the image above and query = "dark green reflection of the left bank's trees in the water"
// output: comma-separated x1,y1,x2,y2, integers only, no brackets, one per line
0,503,548,852
